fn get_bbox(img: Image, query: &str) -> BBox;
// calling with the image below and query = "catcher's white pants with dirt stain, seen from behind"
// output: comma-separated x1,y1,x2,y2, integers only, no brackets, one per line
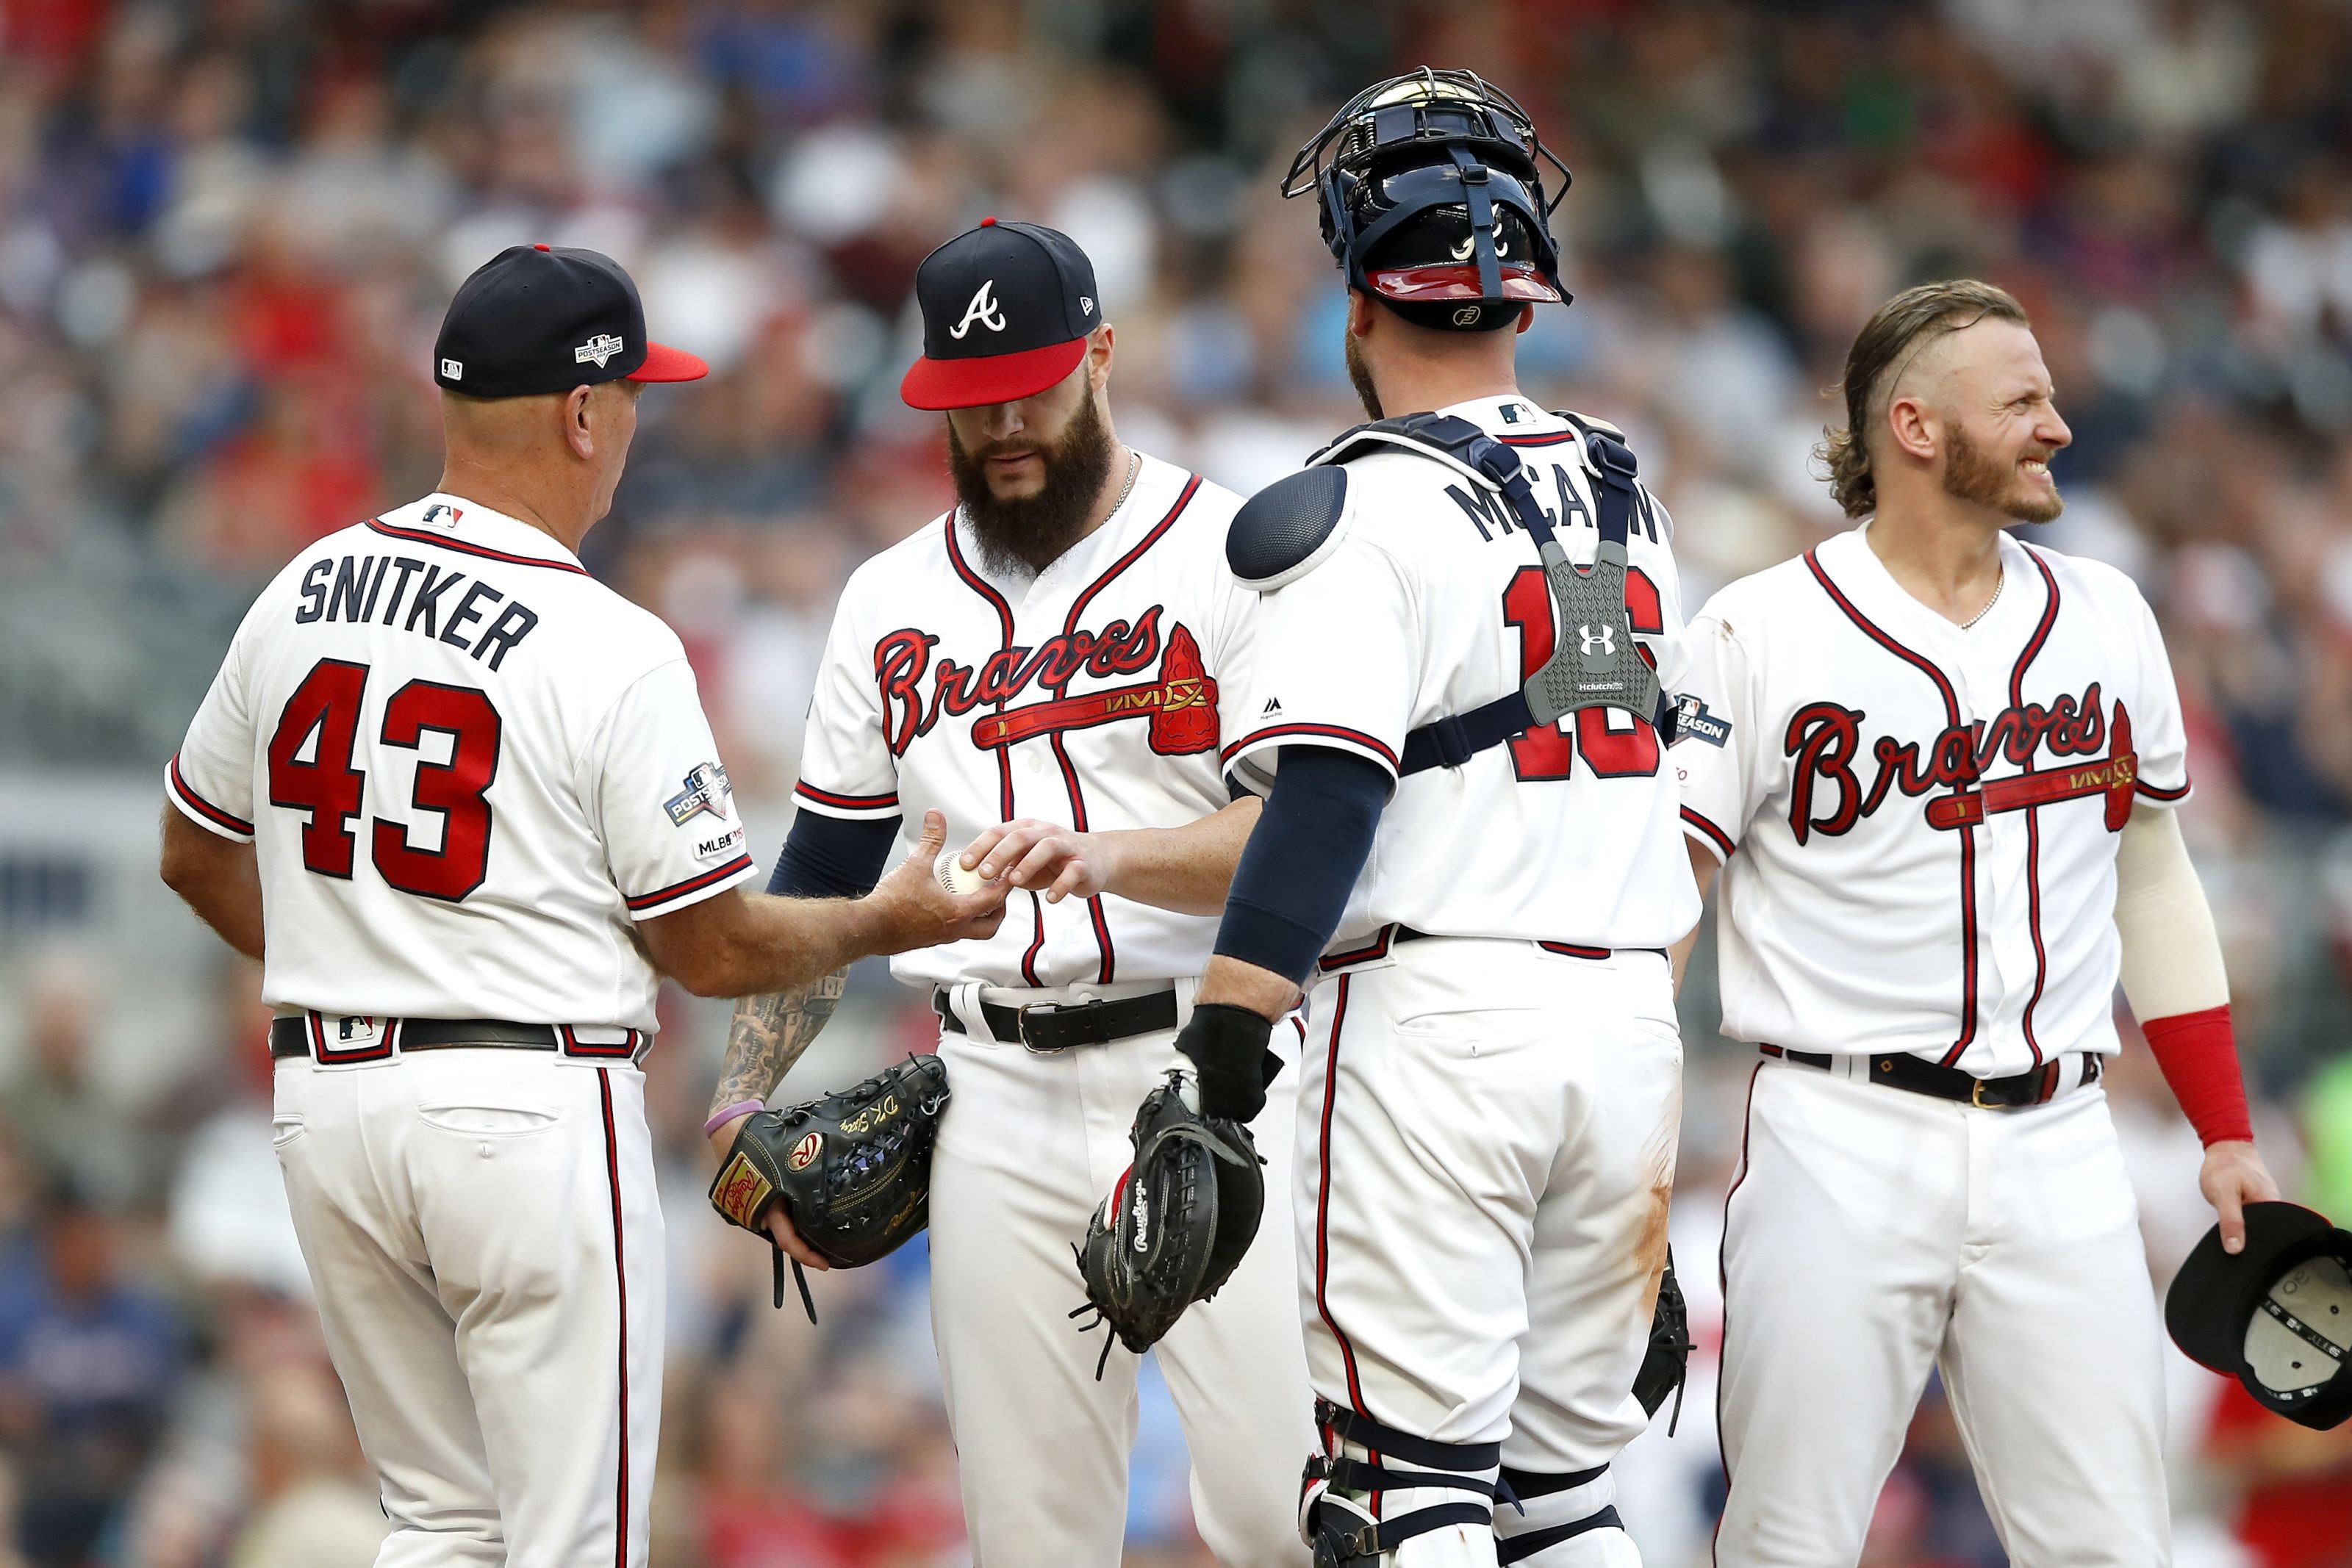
1298,938,1682,1568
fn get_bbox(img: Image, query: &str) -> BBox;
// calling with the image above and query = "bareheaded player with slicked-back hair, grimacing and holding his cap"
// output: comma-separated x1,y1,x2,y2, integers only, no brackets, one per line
1672,280,2277,1568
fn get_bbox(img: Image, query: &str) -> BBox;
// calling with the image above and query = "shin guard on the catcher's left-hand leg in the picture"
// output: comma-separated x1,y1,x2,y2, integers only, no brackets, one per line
1298,1399,1507,1568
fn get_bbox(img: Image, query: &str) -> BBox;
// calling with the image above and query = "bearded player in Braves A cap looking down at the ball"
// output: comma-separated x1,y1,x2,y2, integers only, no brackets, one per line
710,219,1313,1568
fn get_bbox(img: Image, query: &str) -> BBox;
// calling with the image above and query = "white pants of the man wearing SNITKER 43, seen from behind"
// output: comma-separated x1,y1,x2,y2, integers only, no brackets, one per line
275,1049,663,1568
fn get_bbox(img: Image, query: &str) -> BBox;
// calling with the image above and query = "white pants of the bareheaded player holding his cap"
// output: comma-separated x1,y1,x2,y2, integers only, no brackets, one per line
1715,1060,2171,1568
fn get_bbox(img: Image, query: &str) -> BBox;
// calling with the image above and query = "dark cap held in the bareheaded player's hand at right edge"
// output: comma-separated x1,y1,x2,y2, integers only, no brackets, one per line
2164,1204,2352,1431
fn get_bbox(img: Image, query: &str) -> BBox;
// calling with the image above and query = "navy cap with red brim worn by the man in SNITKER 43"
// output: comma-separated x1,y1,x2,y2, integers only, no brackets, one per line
433,245,710,398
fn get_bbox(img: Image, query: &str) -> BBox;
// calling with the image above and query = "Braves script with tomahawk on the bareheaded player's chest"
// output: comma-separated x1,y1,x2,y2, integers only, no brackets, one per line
1785,682,2138,844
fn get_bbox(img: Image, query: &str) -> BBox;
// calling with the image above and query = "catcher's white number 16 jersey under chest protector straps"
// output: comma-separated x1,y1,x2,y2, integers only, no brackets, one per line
1225,398,1698,952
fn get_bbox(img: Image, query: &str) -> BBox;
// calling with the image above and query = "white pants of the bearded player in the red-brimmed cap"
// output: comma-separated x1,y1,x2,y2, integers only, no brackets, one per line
931,982,1313,1568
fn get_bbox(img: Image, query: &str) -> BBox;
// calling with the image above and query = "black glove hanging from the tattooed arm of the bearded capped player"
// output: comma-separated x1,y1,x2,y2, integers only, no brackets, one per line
710,1056,948,1323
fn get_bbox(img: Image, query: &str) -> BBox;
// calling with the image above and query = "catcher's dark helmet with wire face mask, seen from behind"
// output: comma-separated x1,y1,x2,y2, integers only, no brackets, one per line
1282,66,1568,331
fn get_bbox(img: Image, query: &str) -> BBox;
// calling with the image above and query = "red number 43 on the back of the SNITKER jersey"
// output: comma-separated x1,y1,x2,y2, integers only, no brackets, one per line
270,658,498,903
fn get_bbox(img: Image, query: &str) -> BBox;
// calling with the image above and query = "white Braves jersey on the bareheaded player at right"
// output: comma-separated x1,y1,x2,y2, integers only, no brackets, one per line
1670,524,2190,1076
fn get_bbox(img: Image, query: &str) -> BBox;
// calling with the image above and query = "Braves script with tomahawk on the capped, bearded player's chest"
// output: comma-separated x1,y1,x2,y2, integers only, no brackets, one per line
875,604,1216,757
